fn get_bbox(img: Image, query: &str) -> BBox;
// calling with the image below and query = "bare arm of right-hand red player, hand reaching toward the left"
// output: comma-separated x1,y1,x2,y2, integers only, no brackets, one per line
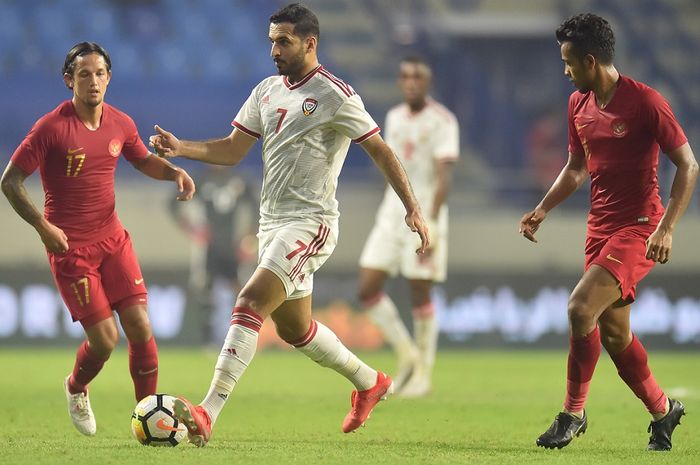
518,152,588,242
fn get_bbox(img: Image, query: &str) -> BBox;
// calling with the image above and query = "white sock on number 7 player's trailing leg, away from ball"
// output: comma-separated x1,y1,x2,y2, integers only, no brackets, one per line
294,320,377,391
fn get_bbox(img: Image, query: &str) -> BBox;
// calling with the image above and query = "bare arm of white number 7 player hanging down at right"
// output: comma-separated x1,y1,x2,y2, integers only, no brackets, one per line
360,134,430,254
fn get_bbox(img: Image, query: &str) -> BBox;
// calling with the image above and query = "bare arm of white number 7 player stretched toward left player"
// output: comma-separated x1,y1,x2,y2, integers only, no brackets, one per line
149,124,257,166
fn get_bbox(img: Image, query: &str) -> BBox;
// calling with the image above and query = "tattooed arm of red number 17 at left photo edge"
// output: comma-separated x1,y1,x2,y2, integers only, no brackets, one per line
0,162,68,253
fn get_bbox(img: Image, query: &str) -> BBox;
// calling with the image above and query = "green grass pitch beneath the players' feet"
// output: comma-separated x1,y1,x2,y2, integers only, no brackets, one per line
0,348,700,465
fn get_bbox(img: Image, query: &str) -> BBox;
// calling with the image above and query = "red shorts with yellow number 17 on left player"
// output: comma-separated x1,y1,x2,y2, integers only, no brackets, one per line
48,228,147,329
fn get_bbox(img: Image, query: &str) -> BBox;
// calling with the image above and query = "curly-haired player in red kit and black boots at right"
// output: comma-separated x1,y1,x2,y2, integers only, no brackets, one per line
520,14,698,450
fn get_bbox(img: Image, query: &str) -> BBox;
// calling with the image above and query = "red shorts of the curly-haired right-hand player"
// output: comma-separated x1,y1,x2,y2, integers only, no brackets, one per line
585,224,656,303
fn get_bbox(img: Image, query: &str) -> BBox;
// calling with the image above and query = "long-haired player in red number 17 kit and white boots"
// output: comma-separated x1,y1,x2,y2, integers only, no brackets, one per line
0,42,195,436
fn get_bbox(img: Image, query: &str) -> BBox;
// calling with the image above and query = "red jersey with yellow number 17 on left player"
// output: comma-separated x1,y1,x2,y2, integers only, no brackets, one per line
11,100,148,248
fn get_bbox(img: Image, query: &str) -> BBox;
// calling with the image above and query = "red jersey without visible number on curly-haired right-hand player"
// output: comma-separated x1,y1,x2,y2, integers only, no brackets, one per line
569,75,688,237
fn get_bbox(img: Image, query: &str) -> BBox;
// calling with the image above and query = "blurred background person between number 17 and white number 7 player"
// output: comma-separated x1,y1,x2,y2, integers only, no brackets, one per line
171,165,258,344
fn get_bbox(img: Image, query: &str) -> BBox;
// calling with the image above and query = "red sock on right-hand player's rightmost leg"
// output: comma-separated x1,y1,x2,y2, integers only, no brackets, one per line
610,335,666,414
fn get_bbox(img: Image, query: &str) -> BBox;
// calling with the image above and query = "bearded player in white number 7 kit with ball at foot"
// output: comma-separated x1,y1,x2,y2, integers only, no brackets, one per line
150,4,429,446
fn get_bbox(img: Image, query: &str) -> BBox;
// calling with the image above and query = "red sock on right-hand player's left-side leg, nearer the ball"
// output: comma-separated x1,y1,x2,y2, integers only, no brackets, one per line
564,326,600,412
